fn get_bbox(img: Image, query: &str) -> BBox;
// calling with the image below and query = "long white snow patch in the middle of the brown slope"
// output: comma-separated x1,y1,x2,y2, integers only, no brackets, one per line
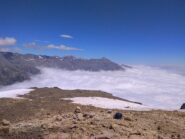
65,97,152,110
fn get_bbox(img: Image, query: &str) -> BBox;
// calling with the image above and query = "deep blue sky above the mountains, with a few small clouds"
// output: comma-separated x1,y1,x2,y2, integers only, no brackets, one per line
0,0,185,64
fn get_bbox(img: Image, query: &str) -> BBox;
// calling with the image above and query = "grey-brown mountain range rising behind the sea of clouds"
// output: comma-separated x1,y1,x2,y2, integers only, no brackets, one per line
0,52,128,85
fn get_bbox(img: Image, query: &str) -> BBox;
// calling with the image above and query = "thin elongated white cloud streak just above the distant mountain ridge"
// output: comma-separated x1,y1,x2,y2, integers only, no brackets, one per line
47,44,82,51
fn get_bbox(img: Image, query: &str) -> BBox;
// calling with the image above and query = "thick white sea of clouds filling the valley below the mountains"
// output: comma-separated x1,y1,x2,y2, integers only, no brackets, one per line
0,66,185,109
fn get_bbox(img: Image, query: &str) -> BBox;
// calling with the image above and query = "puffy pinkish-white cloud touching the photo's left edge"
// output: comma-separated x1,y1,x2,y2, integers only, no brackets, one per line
0,37,17,46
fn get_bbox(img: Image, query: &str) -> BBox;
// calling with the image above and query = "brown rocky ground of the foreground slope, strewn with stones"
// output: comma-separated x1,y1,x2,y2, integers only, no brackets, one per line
0,88,185,139
